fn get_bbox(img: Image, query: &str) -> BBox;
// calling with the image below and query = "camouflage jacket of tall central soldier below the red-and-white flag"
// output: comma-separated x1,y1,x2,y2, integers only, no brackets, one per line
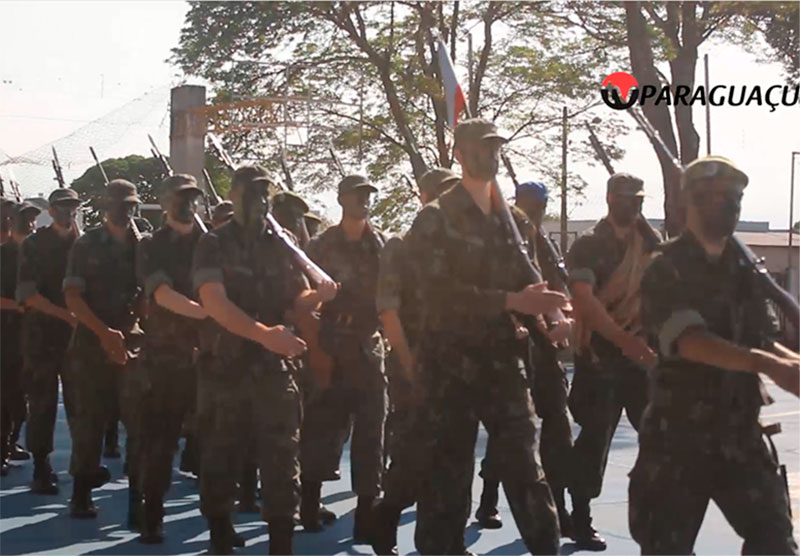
405,183,529,360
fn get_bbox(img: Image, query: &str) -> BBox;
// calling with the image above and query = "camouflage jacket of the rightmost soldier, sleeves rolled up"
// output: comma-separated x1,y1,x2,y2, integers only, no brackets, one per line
640,232,776,442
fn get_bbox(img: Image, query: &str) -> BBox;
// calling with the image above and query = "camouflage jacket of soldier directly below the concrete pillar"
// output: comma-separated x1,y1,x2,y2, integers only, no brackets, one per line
139,225,200,348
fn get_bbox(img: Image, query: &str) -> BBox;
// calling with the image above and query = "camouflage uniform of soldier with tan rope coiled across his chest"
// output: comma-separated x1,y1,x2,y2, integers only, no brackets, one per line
567,218,647,500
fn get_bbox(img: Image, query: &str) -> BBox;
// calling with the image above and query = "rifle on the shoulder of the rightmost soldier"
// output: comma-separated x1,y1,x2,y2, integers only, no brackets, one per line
627,106,800,330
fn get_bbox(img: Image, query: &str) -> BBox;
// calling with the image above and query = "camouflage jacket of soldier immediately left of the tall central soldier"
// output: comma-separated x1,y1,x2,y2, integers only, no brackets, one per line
306,225,386,339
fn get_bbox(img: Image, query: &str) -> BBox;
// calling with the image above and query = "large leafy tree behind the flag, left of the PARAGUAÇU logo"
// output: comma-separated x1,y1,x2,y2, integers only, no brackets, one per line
172,1,619,229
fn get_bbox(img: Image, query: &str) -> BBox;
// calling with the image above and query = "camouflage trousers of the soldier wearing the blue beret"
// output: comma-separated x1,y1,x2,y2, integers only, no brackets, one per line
480,340,572,491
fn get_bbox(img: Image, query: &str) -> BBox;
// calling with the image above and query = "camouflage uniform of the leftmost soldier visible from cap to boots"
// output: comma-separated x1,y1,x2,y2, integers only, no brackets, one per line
16,227,76,459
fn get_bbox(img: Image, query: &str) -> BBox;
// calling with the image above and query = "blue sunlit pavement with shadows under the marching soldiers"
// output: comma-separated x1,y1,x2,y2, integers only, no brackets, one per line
0,372,800,555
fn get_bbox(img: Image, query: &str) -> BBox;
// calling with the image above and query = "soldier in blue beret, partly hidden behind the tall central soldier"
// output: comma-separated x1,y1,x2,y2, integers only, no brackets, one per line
475,181,572,537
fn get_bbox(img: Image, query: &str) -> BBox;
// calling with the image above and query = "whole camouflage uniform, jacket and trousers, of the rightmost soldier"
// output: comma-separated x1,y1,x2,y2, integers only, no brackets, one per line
629,240,797,554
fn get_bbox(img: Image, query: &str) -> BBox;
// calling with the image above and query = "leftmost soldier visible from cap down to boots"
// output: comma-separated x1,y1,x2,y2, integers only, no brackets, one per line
16,188,81,494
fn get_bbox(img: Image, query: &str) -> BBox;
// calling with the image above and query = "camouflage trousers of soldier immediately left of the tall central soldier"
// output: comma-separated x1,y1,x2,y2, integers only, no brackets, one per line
300,338,388,496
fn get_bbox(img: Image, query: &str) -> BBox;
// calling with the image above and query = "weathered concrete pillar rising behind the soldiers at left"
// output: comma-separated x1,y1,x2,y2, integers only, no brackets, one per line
169,85,206,189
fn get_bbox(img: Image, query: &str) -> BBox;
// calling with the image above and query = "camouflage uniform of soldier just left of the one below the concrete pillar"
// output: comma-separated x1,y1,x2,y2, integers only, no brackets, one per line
62,226,141,484
